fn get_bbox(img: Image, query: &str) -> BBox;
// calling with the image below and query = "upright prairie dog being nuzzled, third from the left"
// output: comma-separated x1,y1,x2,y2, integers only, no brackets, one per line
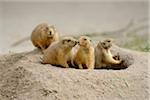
72,36,95,69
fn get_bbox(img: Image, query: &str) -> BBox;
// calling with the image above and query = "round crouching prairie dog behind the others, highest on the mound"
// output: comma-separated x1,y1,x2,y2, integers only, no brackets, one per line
31,23,59,50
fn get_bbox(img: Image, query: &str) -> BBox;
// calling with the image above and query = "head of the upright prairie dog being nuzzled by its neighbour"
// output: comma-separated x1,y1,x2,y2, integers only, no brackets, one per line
79,36,92,48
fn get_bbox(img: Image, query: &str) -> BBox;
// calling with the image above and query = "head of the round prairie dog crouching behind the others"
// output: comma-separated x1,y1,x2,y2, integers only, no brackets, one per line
44,25,57,38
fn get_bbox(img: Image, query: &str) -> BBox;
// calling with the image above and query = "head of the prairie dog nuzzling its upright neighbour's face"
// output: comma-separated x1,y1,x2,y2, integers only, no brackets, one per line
61,37,78,48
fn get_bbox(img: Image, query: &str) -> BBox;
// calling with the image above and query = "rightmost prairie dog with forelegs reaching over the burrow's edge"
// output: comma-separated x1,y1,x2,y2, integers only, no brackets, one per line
95,39,121,68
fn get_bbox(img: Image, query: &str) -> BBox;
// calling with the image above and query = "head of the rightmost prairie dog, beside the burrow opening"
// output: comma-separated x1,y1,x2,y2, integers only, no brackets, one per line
98,39,113,49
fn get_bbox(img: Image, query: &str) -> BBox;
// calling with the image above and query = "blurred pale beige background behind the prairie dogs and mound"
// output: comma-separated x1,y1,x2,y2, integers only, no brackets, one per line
0,0,150,53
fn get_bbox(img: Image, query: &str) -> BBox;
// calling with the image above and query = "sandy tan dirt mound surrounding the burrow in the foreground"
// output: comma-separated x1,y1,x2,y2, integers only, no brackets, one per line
0,48,149,100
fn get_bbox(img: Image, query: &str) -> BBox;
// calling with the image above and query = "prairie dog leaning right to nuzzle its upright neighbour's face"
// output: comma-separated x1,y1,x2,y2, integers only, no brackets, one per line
42,37,78,68
